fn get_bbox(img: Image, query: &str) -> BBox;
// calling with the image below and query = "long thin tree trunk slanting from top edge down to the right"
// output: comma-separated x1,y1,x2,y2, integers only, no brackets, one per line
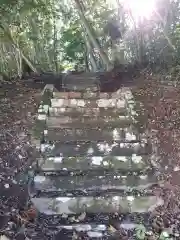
74,0,112,70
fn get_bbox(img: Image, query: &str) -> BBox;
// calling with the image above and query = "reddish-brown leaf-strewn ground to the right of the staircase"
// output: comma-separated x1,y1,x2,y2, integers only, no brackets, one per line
134,77,180,215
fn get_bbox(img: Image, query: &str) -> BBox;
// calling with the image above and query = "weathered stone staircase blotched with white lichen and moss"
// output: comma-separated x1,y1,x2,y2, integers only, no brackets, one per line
29,81,163,238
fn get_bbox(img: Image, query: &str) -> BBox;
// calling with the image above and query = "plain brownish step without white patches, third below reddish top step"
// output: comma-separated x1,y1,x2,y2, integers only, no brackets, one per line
46,116,133,129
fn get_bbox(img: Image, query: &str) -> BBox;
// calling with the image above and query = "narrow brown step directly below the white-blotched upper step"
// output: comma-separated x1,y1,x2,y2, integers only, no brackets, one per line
49,107,127,118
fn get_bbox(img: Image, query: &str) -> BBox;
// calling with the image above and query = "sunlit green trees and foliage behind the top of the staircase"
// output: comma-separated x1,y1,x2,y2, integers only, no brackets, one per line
0,0,180,76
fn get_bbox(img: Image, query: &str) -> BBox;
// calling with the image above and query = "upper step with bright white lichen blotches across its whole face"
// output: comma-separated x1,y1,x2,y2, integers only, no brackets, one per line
51,99,127,108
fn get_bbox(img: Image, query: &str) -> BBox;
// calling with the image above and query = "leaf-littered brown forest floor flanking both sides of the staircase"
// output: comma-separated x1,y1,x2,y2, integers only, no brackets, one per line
0,76,180,239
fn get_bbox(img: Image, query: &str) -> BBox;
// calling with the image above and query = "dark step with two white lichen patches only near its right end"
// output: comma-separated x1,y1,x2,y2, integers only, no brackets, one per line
44,126,140,142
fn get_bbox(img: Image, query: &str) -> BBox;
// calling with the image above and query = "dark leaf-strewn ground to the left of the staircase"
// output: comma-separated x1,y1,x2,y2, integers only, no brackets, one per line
0,83,39,236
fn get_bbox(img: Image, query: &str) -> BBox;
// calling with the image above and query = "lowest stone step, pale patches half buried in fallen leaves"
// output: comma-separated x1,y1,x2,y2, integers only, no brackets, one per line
40,223,143,240
